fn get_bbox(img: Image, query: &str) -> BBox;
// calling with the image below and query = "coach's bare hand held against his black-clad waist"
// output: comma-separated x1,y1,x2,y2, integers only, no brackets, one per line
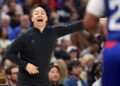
26,63,39,74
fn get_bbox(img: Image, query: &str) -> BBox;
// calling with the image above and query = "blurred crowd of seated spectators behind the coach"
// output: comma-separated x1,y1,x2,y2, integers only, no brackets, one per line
0,0,106,86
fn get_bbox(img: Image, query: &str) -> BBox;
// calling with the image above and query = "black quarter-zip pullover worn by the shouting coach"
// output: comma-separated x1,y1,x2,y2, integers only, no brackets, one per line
5,21,83,80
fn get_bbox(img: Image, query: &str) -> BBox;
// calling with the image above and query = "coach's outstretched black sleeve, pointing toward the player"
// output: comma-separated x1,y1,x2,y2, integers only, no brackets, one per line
53,20,84,37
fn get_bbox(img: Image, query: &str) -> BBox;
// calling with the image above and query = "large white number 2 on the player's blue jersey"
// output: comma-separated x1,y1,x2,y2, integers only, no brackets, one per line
109,0,120,31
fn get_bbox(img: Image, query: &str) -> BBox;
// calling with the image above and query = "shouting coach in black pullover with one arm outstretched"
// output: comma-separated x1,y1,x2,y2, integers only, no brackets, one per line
5,7,83,86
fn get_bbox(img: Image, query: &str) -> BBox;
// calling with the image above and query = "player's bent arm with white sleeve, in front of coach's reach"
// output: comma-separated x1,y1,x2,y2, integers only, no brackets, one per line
84,0,105,32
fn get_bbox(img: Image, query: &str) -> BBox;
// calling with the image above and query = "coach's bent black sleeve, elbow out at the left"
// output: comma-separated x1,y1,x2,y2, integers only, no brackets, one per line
4,34,27,68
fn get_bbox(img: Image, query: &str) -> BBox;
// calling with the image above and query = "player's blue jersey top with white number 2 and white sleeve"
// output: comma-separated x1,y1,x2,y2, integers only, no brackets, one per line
86,0,120,41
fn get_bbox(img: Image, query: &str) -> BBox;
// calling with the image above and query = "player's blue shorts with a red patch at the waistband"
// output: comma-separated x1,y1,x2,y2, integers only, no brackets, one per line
102,41,120,86
